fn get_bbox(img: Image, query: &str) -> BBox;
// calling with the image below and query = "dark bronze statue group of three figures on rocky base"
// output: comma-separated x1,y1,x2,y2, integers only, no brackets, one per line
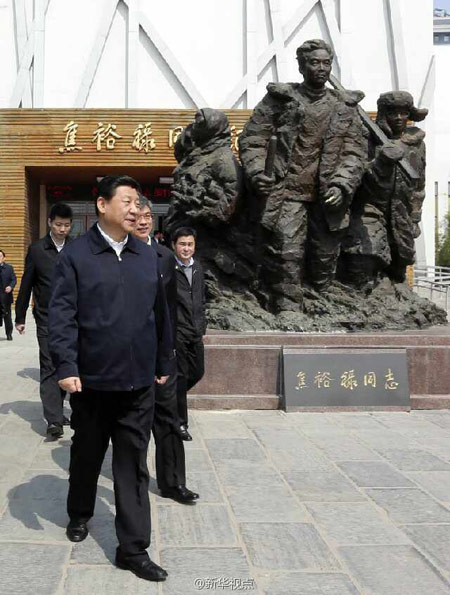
168,40,427,328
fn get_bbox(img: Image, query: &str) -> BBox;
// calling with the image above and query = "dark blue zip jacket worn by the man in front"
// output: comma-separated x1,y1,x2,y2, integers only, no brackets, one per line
49,224,173,391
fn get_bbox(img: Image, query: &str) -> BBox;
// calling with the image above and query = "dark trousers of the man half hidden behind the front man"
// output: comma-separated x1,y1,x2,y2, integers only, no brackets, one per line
153,360,186,491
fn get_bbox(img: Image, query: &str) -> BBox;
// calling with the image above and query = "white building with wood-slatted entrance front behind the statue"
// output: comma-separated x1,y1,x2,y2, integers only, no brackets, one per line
0,0,437,274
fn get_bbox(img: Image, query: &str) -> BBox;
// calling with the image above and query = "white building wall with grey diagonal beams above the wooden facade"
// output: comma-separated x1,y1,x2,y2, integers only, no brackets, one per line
0,0,436,264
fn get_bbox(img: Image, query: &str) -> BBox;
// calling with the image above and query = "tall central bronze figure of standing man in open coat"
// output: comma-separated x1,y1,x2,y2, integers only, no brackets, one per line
240,39,367,311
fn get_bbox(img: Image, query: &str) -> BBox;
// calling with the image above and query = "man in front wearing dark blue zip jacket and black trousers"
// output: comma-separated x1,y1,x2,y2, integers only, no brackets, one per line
49,176,173,581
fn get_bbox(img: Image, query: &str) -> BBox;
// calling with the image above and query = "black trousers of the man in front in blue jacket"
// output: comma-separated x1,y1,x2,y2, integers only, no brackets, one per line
67,386,155,560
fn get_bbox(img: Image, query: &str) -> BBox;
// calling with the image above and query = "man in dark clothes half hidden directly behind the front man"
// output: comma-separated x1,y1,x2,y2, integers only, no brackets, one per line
133,195,199,504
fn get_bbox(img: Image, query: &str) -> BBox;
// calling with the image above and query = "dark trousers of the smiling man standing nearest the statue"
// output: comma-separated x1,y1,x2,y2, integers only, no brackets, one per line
177,337,205,426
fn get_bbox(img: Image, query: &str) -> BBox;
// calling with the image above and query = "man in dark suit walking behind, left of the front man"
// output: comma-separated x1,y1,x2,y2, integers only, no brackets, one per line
16,203,73,440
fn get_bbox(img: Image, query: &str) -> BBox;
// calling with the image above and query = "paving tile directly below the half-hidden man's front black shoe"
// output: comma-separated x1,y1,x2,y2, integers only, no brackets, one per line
157,503,236,547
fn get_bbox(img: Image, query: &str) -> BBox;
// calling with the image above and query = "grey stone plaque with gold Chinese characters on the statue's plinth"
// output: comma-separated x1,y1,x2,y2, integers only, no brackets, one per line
282,348,410,411
